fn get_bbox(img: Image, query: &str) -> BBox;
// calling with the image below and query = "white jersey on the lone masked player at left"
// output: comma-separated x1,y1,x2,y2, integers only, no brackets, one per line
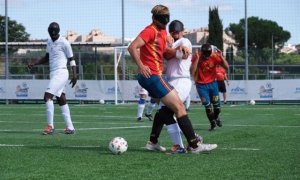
46,36,73,71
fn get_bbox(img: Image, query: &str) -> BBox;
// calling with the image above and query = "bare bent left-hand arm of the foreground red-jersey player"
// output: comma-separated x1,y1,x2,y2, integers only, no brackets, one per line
128,36,151,77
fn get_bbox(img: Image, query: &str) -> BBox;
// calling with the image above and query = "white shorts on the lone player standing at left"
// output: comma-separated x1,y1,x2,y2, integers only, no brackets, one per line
46,69,69,97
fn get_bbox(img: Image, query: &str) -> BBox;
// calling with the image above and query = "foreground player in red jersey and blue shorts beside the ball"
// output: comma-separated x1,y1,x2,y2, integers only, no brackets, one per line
128,5,217,153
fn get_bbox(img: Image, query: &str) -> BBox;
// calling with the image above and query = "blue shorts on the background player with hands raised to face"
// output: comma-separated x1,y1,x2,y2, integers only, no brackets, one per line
196,81,220,107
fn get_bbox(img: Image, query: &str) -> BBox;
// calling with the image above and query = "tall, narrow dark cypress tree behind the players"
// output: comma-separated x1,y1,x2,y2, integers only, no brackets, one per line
207,7,223,51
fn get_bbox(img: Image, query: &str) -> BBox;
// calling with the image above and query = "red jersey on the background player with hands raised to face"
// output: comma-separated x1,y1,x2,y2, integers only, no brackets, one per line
192,52,222,84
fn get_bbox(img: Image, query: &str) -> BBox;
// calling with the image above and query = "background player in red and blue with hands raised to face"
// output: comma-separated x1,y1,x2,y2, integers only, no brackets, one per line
191,44,229,131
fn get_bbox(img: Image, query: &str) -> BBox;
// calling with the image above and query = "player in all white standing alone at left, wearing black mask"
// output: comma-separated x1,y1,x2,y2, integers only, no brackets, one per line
28,22,77,135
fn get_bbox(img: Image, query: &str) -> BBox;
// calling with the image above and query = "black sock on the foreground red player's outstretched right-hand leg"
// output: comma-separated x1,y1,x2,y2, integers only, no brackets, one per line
177,115,198,148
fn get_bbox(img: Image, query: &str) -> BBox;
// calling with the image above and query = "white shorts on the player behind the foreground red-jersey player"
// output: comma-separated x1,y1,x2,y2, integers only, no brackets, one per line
159,78,192,107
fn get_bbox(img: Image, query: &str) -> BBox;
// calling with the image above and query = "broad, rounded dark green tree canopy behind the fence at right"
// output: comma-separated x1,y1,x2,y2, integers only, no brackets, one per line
225,17,291,49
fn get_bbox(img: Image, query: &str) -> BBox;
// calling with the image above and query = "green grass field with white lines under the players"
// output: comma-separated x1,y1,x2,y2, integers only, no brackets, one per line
0,104,300,180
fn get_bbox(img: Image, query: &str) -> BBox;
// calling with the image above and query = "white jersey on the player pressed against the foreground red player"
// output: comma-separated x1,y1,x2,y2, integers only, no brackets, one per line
166,38,192,79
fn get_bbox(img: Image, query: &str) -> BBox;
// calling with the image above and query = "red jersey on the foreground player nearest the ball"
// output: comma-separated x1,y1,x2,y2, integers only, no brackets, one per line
139,24,167,75
